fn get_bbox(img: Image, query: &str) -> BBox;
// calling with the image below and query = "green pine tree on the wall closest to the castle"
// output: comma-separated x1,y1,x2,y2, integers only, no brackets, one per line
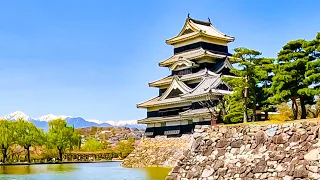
223,48,274,122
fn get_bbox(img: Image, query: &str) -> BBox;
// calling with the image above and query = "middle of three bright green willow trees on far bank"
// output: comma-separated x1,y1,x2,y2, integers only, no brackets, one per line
15,119,44,162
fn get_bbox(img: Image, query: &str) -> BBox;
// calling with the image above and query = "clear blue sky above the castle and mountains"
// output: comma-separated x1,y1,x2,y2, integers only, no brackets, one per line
0,0,320,121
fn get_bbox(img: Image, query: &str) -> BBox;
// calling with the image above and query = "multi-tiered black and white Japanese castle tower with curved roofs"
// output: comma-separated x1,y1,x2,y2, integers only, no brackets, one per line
137,15,234,137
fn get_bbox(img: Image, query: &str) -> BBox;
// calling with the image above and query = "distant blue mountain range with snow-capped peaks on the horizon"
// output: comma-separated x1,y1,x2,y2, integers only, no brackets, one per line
0,111,146,131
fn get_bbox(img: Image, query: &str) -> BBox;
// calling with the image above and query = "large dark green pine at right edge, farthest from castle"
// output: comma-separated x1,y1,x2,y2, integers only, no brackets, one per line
269,34,320,119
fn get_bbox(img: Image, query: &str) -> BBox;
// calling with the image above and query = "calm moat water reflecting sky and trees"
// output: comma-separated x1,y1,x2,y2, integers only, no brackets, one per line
0,162,170,180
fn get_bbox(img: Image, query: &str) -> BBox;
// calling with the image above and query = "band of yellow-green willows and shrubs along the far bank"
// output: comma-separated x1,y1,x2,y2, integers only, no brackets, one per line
0,119,135,163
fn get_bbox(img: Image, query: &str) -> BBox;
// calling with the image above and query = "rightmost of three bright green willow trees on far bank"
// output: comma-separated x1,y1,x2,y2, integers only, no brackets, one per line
47,119,81,160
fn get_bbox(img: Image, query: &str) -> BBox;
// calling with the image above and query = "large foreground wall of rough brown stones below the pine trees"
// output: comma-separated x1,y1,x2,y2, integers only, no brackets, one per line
167,120,320,180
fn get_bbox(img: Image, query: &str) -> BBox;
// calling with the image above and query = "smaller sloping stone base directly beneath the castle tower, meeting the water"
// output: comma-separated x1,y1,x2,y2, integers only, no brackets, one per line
122,135,191,168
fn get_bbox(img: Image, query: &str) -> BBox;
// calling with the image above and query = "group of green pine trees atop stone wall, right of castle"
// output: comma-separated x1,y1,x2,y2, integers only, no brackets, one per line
213,33,320,123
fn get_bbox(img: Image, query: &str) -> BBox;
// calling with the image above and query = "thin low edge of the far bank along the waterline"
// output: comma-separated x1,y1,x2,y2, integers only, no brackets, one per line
0,160,123,166
